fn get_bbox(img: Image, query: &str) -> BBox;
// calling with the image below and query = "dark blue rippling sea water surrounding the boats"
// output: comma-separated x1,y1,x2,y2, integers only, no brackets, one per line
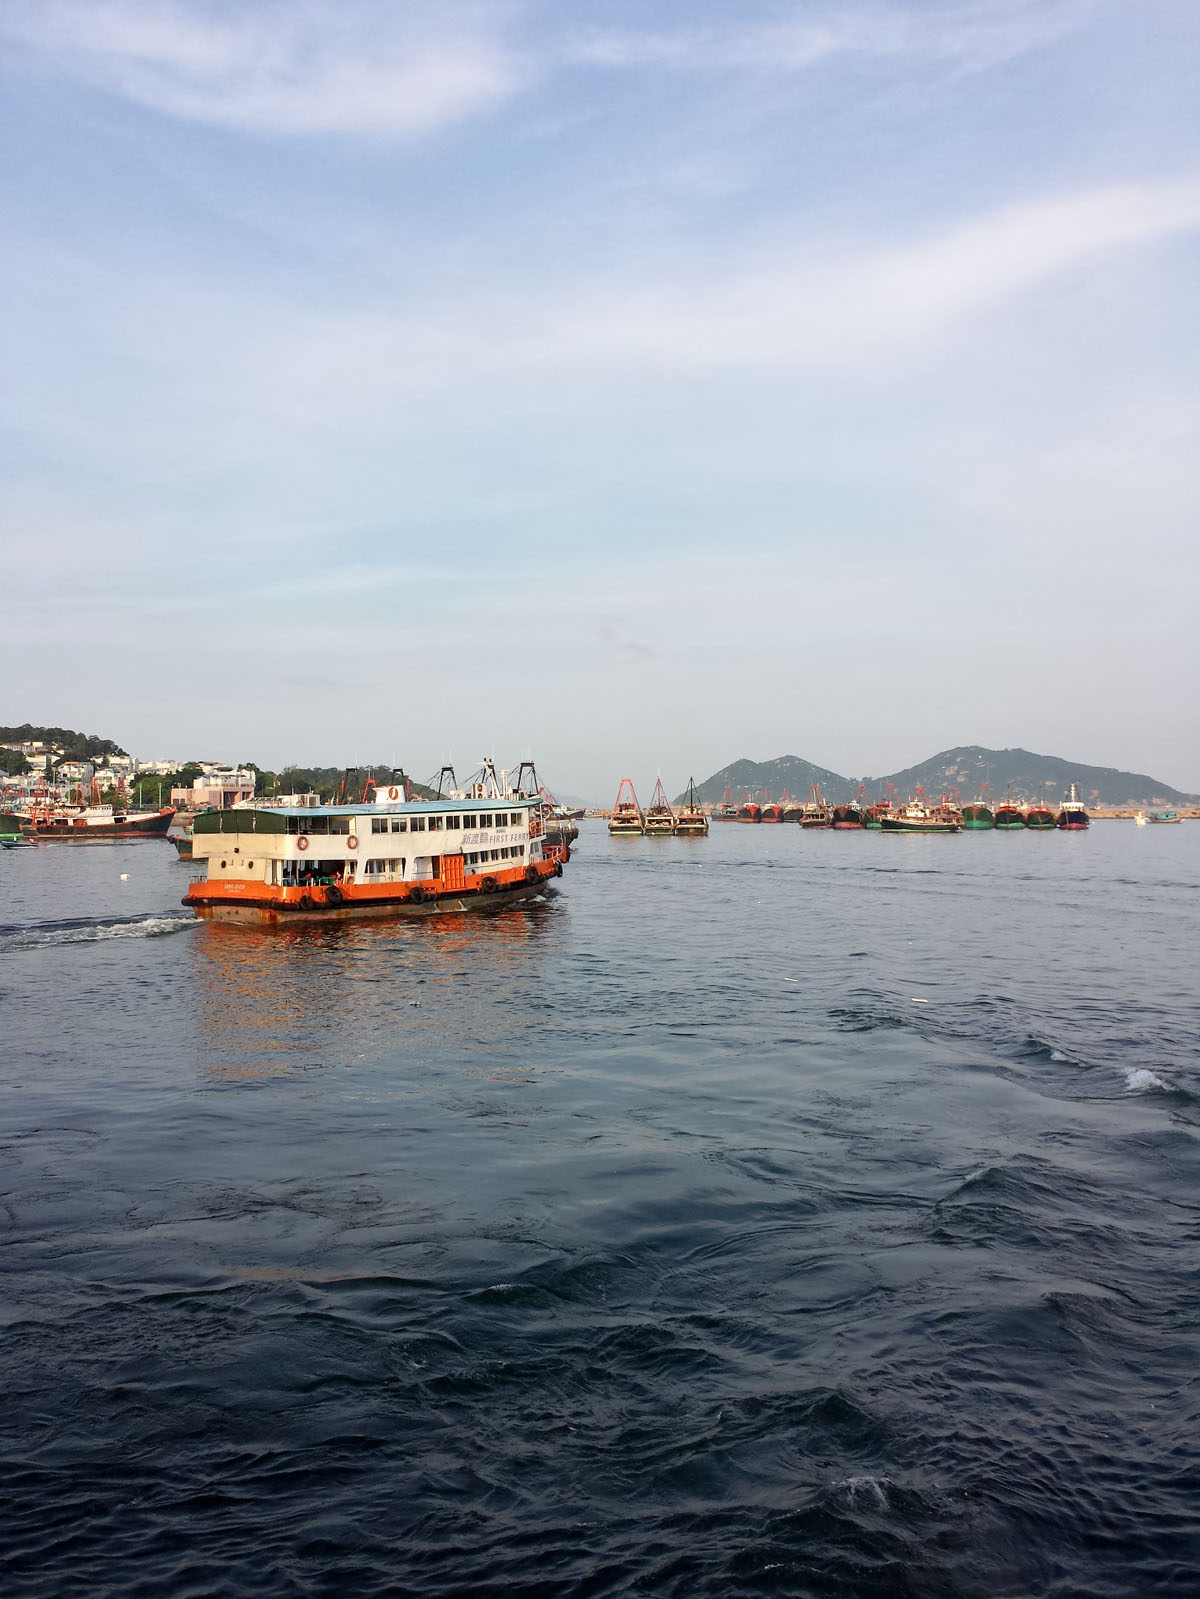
0,823,1200,1599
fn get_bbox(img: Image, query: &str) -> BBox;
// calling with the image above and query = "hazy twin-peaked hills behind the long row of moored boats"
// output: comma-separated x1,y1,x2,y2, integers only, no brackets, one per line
696,744,1195,807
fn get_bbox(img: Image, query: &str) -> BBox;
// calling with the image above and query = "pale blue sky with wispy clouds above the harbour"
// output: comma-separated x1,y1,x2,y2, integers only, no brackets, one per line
0,0,1200,801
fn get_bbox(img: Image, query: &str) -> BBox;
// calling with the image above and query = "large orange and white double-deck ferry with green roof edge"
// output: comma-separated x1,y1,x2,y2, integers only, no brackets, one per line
184,761,570,923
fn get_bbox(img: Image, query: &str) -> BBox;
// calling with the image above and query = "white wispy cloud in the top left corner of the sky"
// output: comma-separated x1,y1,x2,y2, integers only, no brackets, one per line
0,0,522,136
